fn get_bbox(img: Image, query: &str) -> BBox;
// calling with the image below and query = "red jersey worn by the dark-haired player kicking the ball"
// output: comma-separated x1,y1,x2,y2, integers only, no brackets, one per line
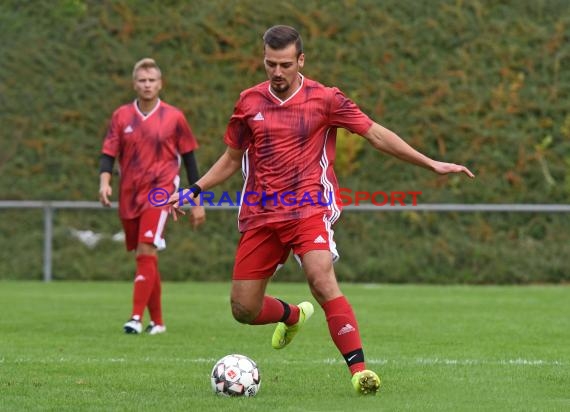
224,76,372,232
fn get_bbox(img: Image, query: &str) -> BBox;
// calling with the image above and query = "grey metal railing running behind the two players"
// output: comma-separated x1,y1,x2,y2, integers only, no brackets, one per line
0,200,570,282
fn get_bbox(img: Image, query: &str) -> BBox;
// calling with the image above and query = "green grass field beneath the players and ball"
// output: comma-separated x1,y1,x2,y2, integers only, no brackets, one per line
0,282,570,411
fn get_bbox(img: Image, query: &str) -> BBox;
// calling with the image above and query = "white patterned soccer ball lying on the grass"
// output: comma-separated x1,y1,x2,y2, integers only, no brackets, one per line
211,354,261,396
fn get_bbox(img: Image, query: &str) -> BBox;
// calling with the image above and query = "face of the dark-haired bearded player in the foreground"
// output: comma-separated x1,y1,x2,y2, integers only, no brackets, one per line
264,44,305,100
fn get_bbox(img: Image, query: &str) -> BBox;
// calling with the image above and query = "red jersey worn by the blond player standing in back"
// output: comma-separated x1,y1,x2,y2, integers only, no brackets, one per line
102,100,198,219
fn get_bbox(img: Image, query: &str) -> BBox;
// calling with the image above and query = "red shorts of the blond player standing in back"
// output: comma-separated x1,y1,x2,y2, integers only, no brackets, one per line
121,207,168,250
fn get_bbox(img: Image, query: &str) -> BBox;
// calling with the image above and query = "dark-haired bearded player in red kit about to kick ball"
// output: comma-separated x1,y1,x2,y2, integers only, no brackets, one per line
169,26,474,394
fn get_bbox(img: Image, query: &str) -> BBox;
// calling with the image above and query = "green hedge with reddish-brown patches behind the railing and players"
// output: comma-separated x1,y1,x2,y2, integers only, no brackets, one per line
0,0,570,283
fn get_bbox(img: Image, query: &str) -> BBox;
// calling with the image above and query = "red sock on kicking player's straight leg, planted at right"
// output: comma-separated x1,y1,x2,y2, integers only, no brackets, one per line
322,296,366,374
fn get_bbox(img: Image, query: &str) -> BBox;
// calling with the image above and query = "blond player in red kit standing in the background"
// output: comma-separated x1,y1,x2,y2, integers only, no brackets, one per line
99,58,205,335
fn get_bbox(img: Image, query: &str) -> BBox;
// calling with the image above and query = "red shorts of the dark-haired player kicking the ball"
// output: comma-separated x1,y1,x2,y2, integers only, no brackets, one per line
233,214,338,280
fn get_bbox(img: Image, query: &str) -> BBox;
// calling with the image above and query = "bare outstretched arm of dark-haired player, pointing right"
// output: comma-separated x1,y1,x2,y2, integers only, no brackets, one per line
362,122,475,177
